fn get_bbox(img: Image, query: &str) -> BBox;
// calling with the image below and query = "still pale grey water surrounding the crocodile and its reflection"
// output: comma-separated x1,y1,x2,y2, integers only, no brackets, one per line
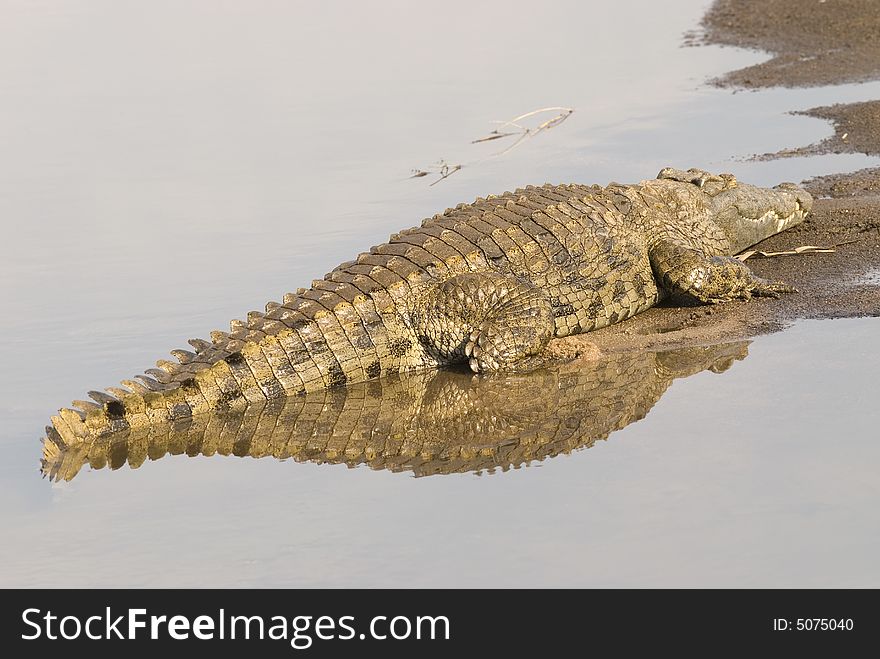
0,0,880,586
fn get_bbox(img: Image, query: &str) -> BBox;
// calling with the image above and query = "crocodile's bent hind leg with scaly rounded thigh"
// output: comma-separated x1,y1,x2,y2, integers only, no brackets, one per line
410,272,555,373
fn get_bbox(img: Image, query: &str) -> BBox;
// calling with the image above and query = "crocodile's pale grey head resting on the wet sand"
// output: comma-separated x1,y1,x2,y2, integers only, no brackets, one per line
657,167,813,254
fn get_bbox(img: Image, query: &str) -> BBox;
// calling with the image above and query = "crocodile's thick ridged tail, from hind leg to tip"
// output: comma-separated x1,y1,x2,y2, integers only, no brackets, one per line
46,280,408,448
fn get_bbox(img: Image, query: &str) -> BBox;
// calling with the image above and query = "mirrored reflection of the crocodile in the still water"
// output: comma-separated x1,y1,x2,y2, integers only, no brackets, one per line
42,342,748,480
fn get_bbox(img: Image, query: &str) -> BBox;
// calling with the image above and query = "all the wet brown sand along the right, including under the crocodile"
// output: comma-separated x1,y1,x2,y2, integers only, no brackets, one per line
551,0,880,358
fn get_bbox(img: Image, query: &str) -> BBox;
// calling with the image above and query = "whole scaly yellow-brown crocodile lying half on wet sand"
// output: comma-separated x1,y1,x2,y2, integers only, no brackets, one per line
47,168,812,445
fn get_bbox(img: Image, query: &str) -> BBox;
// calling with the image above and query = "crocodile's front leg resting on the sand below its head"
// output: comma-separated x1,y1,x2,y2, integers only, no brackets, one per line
649,239,795,304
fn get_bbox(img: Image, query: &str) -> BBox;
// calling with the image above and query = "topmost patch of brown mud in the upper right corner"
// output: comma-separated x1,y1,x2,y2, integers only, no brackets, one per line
702,0,880,88
